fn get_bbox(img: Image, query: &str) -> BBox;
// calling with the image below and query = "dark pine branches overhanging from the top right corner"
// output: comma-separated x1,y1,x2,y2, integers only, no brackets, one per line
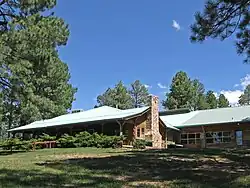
190,0,250,63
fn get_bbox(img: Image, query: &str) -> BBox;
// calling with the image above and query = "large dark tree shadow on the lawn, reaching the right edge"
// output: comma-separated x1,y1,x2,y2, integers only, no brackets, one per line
37,150,250,188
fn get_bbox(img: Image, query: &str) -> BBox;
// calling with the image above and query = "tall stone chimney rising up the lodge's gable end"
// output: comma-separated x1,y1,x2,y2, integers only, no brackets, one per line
145,95,162,148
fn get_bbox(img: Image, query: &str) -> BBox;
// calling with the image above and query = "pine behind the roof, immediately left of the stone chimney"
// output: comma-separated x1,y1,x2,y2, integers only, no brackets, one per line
129,80,150,108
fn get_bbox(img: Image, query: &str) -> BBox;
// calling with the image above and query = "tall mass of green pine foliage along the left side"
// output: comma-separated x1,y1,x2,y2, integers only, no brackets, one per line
0,0,76,138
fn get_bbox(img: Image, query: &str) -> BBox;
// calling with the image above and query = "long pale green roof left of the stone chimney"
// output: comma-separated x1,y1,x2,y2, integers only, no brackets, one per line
8,106,150,132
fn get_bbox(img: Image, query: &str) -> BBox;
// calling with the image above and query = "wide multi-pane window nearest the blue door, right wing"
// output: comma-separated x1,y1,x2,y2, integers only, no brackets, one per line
206,131,231,144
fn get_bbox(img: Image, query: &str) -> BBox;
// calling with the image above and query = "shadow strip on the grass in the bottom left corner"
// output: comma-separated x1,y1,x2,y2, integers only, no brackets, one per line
0,169,122,188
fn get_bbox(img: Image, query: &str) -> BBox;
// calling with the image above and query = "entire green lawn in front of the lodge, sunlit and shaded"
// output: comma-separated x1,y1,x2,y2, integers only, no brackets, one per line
0,148,250,188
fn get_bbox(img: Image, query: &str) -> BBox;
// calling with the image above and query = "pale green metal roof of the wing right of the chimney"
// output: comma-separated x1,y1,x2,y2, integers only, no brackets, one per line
161,106,250,128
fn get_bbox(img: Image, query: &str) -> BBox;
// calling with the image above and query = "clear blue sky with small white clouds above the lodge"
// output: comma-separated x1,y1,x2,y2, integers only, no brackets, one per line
55,0,250,109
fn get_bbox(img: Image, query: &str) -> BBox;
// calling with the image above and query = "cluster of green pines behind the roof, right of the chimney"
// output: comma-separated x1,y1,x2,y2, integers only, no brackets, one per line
162,71,229,110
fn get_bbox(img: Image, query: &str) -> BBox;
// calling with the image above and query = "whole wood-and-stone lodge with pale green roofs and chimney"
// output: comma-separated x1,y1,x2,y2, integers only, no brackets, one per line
8,96,250,148
